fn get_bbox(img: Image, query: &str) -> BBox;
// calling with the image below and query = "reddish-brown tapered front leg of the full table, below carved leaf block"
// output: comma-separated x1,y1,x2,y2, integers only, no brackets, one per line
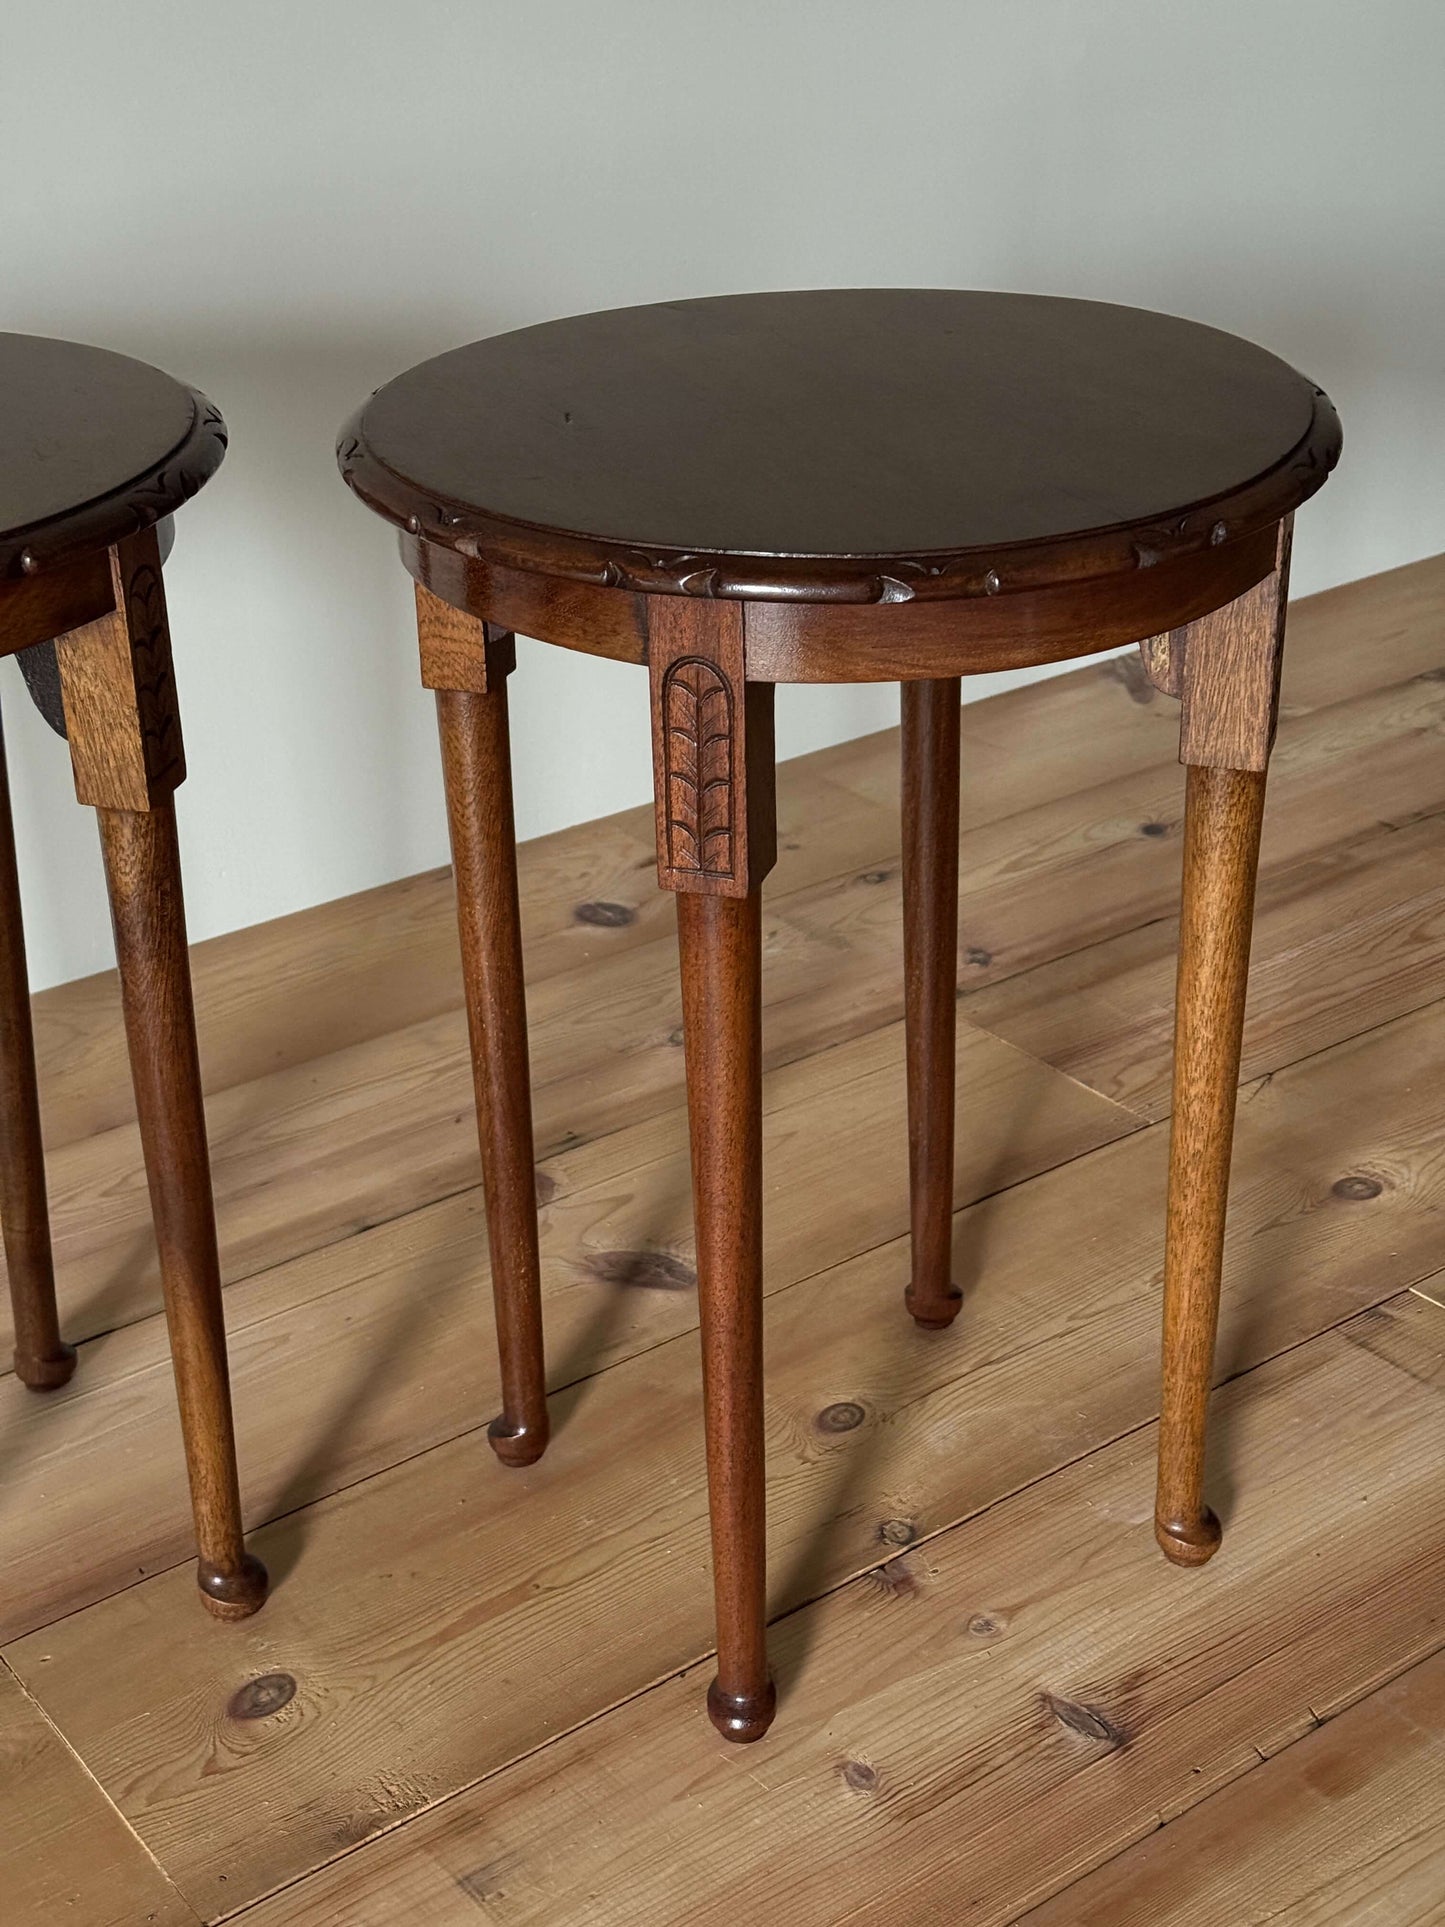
678,890,775,1740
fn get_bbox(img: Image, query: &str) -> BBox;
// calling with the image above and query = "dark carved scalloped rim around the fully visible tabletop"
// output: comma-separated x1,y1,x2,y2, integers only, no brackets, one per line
337,389,1343,603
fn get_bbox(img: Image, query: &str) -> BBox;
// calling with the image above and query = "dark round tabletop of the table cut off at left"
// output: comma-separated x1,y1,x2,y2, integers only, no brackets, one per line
0,333,225,578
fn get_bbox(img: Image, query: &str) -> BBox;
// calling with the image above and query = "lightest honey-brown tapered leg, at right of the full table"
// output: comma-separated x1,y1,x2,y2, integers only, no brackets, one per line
1154,767,1264,1565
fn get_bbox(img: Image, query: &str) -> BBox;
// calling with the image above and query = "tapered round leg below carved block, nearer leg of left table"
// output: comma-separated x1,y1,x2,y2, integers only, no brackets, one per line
96,796,266,1619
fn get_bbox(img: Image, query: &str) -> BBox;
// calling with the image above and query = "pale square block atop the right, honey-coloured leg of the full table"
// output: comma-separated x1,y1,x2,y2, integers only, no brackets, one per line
1139,516,1293,769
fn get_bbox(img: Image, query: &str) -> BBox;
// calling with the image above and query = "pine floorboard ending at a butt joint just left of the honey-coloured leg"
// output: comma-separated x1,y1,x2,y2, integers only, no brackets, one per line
0,1025,1135,1638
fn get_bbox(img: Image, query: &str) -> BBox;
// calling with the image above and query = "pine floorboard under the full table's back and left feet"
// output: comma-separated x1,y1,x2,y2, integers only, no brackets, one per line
6,1017,1445,1910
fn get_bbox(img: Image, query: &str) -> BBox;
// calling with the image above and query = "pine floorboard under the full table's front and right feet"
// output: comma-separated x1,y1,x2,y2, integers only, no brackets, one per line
237,1299,1445,1927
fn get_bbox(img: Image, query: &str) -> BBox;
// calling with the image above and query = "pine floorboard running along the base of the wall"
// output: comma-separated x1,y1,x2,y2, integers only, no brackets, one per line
16,557,1445,1145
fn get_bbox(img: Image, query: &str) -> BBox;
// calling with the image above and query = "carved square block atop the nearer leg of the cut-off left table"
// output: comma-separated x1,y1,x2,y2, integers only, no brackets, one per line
56,528,185,809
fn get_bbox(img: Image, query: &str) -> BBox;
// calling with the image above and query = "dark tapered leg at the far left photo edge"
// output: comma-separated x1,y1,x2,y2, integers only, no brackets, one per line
0,709,75,1391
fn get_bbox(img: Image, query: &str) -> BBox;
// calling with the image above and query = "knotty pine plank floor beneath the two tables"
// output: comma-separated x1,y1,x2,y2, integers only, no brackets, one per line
0,559,1445,1927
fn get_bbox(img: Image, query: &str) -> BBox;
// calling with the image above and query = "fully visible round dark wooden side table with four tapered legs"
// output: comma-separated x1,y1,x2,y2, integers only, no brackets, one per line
339,289,1339,1740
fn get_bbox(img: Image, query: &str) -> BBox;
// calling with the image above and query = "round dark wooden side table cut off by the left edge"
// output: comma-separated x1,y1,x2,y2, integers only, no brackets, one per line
0,335,266,1619
